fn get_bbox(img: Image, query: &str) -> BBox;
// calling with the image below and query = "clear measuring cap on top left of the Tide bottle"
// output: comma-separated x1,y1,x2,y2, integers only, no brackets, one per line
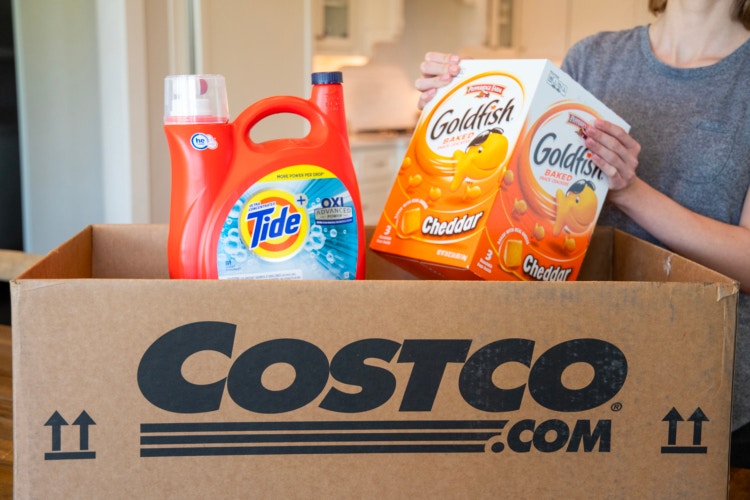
164,75,229,123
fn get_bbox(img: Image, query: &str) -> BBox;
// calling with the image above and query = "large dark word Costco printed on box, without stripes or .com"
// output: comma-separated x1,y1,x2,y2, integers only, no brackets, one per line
138,322,628,414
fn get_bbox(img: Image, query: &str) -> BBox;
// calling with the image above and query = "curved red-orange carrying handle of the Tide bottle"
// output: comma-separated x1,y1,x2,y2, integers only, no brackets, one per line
234,96,329,153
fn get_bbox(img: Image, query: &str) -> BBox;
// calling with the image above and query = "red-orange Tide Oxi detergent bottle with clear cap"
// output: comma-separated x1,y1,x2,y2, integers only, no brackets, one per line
164,72,366,280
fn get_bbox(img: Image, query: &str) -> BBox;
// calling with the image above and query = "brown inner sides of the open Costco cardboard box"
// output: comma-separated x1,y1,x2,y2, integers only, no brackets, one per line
18,224,739,288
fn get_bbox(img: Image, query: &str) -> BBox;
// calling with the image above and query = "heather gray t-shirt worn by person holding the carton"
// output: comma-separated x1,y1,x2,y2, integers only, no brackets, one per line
562,26,750,429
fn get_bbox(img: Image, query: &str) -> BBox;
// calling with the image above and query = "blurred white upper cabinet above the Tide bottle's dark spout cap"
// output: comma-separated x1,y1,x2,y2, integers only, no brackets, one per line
313,0,404,56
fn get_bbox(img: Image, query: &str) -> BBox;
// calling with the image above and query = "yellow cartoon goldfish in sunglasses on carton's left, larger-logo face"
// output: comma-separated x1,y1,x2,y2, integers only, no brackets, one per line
450,128,508,191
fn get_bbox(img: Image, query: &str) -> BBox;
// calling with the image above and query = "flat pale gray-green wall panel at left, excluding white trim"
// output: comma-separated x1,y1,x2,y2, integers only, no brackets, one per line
13,0,104,253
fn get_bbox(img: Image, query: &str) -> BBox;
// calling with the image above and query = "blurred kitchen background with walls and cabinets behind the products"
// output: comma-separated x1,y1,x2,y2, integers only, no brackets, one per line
0,0,651,253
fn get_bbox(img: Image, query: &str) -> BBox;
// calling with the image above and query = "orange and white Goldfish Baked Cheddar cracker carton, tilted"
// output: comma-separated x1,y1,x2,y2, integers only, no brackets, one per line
370,59,630,281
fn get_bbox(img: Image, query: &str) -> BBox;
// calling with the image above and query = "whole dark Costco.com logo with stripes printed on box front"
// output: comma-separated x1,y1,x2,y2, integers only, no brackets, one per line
132,322,628,457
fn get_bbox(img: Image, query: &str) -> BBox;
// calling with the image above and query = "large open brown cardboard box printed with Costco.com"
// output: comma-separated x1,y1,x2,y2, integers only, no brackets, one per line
12,225,739,499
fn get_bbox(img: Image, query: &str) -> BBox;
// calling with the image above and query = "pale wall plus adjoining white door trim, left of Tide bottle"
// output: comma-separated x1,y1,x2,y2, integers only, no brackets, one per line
13,0,150,253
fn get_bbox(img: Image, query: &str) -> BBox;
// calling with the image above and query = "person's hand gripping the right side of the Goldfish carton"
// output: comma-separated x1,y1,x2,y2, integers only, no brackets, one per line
585,120,641,193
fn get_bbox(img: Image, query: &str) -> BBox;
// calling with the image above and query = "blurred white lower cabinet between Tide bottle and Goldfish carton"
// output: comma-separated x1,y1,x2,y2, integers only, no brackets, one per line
352,136,409,225
